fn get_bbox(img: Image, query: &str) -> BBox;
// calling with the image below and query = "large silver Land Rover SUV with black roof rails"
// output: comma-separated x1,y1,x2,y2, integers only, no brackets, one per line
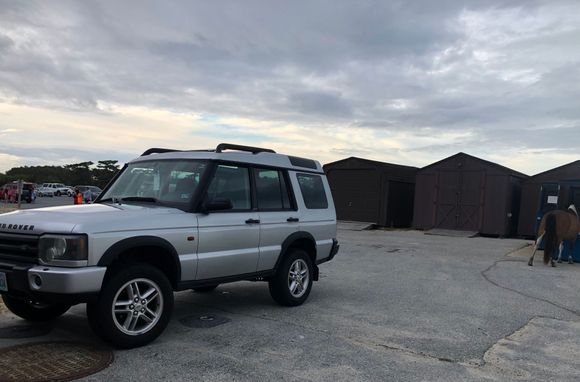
0,144,339,348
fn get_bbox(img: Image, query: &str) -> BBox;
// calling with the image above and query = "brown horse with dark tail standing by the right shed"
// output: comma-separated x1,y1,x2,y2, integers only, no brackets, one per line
528,204,580,267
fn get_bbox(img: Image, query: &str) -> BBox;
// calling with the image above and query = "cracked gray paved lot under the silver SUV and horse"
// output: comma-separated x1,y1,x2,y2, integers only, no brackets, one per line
0,222,580,381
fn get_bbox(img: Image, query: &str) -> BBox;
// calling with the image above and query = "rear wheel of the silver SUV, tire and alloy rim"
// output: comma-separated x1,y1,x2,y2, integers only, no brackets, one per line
268,249,313,306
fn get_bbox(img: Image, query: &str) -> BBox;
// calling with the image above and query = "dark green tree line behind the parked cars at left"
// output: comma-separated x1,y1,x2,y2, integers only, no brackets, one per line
0,160,120,188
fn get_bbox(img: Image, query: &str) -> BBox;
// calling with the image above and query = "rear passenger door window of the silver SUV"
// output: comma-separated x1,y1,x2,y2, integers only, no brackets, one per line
254,169,292,210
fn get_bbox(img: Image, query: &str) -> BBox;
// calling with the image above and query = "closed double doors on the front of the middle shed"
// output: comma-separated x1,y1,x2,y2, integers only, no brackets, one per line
435,171,485,231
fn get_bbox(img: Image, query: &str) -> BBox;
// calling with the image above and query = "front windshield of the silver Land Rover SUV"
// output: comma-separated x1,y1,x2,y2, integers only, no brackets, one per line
100,160,207,210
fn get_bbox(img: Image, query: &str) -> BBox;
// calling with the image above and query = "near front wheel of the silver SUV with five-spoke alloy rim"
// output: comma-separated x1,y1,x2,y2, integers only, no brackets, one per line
87,264,173,349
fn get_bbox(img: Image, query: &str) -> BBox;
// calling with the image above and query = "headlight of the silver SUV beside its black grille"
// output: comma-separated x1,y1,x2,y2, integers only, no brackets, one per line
38,235,88,267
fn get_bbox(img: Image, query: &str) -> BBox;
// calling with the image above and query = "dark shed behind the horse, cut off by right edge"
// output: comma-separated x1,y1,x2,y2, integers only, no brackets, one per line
518,160,580,237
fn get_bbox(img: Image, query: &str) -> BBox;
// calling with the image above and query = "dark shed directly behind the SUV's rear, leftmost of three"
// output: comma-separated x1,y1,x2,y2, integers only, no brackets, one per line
324,157,417,227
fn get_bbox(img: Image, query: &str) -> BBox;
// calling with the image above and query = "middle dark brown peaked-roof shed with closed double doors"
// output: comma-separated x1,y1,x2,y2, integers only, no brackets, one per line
413,153,528,236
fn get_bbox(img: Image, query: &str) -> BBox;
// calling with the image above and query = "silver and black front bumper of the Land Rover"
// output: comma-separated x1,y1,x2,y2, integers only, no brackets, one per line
0,262,107,302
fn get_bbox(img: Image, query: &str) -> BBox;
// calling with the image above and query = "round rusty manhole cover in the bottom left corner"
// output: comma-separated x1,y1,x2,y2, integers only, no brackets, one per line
0,342,113,382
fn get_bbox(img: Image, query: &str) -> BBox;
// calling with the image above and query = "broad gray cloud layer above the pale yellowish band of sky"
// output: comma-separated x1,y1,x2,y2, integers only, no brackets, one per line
0,0,580,172
